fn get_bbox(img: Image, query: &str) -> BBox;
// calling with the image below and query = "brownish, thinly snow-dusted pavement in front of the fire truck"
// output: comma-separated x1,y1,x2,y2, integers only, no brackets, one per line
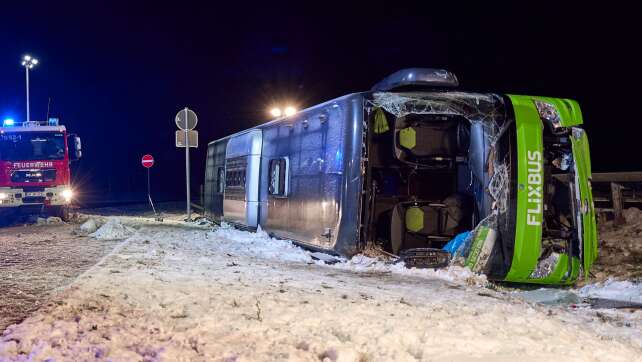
0,219,119,334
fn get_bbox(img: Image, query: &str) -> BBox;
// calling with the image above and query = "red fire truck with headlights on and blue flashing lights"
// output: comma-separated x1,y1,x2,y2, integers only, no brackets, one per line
0,118,82,220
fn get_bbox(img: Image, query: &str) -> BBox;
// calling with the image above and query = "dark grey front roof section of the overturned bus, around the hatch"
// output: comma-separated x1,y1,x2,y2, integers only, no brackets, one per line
260,103,345,250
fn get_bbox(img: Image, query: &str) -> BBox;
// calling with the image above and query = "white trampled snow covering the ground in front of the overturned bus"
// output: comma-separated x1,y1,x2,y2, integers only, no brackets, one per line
0,217,642,361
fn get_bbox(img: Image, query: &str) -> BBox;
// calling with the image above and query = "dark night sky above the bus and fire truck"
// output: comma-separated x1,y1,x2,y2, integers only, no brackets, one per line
0,1,642,204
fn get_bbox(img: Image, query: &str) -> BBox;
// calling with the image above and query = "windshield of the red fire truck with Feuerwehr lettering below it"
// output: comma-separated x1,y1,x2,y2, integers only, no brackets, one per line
0,132,65,161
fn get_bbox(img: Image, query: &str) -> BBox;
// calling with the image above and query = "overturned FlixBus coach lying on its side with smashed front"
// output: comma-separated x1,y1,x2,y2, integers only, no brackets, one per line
204,68,597,284
